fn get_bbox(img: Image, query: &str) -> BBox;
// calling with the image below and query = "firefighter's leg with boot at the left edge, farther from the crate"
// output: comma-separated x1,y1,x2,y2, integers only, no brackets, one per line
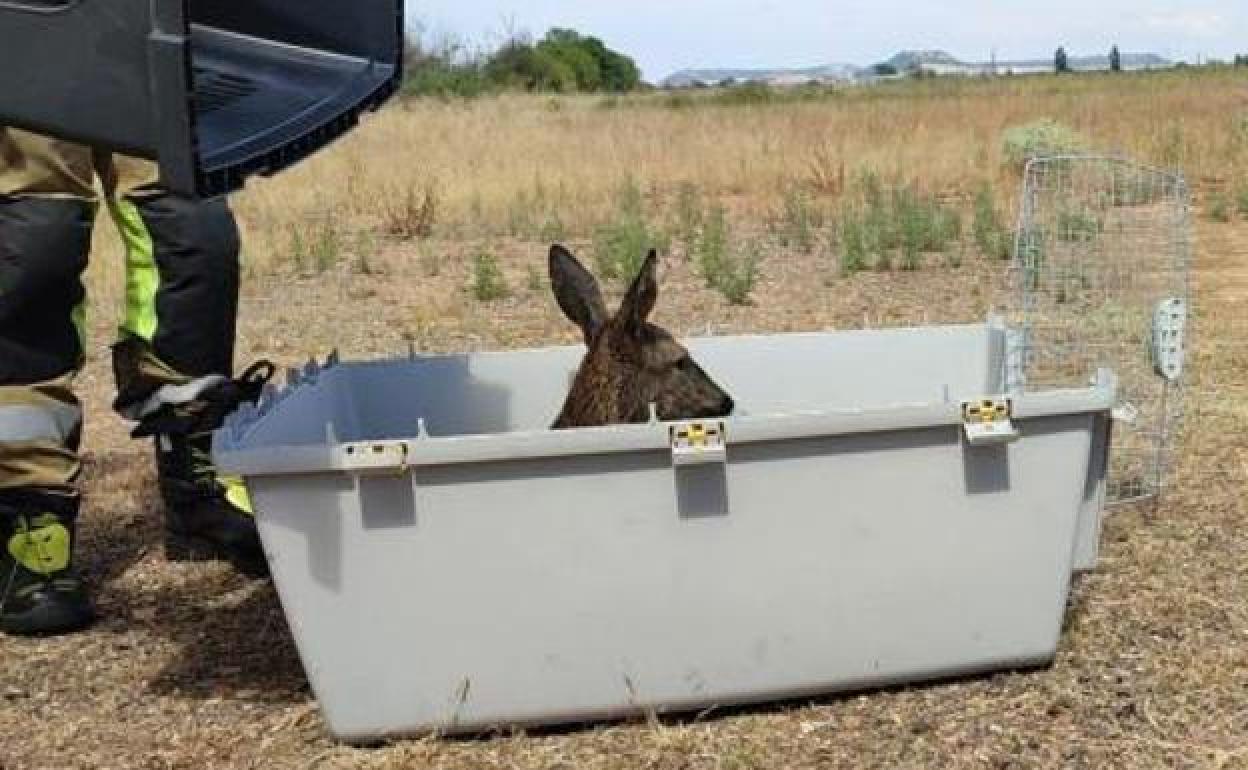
0,127,95,634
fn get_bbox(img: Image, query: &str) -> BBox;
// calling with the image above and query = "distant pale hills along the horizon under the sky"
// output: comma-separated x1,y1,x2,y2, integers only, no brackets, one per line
660,50,1174,89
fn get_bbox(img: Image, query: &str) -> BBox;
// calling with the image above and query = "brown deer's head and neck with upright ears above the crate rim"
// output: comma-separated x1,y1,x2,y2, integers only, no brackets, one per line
550,246,733,429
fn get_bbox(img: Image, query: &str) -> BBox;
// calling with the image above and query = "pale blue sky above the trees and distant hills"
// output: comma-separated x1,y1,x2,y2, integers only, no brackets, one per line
408,0,1248,81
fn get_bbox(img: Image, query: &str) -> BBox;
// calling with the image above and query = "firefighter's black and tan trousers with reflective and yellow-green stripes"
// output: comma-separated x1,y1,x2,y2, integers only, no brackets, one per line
0,126,240,503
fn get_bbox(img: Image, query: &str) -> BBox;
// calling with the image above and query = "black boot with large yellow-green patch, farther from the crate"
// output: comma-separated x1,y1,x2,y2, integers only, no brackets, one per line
0,495,95,636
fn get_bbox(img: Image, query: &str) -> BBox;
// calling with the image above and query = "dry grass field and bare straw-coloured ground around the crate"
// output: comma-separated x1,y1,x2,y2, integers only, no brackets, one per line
7,71,1248,770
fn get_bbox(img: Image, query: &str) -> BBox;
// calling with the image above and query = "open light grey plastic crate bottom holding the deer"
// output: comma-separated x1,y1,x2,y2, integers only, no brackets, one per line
216,318,1116,743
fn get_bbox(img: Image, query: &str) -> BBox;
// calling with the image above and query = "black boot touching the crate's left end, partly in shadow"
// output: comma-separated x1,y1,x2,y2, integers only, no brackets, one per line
156,433,268,578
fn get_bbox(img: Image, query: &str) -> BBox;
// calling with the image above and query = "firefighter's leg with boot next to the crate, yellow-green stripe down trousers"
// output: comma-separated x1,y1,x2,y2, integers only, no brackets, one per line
105,158,267,575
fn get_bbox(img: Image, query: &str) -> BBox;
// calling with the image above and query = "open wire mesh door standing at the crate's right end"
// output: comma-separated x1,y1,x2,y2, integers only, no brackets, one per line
1007,155,1192,503
